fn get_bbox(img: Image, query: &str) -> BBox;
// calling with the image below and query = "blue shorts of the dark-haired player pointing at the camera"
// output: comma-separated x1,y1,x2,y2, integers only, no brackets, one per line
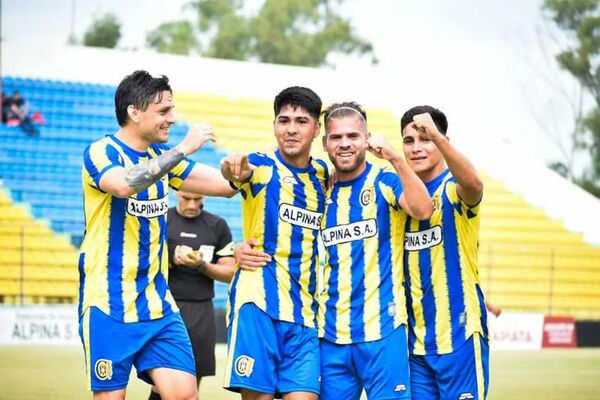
223,303,319,395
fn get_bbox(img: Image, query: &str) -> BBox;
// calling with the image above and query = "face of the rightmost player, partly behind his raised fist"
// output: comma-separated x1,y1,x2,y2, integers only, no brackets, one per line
402,123,445,177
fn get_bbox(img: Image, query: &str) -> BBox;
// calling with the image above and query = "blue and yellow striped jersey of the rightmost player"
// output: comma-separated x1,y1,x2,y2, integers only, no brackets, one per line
404,169,487,355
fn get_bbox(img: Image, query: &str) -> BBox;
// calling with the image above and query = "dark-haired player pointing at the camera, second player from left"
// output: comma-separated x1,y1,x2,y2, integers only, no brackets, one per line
221,86,328,400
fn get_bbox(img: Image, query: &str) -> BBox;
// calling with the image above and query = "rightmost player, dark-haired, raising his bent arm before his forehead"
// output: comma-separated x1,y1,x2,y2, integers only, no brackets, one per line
401,106,489,400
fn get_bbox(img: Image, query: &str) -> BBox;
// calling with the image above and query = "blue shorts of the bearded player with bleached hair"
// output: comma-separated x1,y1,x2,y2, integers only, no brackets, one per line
319,325,410,400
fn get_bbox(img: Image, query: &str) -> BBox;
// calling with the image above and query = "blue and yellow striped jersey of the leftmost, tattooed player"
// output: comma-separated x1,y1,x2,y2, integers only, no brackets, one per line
79,136,194,322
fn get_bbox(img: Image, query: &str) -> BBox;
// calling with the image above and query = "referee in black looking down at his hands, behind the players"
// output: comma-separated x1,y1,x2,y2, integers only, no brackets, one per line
149,191,235,400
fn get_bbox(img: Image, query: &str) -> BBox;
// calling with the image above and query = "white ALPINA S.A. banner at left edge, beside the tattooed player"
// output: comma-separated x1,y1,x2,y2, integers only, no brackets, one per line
0,305,81,345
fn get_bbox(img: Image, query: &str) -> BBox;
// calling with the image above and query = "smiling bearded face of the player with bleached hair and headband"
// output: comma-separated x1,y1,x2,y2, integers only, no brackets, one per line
323,115,369,178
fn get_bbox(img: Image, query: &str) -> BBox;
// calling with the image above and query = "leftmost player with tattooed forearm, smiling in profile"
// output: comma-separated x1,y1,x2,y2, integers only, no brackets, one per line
79,71,235,400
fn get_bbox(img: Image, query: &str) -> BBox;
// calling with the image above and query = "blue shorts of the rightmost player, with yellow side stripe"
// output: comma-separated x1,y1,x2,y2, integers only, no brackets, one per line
410,333,490,400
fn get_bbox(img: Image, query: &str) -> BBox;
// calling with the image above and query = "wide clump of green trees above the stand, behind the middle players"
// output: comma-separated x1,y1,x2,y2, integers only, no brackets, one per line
147,0,377,67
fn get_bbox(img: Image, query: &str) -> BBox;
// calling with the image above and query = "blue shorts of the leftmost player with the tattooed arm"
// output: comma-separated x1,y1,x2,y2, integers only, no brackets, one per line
79,307,196,391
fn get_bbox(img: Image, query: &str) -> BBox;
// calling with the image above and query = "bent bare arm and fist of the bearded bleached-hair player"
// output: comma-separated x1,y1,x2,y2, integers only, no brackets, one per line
367,136,433,220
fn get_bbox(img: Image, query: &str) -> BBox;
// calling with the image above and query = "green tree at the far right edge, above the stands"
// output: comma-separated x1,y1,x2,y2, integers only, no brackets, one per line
543,0,600,197
